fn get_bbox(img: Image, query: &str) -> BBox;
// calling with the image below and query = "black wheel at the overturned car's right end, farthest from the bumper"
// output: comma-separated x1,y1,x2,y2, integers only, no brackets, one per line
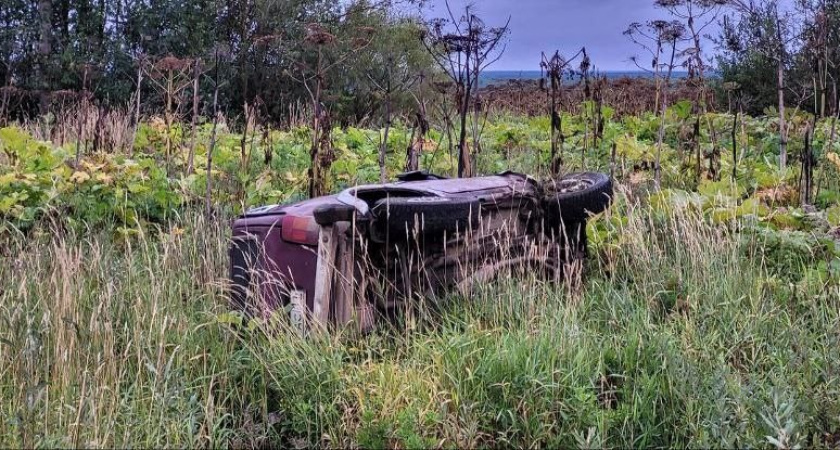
543,172,613,224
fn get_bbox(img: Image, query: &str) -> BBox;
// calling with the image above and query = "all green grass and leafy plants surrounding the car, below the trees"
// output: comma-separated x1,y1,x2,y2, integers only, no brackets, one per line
0,106,840,448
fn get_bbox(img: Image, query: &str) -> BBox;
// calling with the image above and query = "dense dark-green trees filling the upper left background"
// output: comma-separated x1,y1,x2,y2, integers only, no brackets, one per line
0,0,431,121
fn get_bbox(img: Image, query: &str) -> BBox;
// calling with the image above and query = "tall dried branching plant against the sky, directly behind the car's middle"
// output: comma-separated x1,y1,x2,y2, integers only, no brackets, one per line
423,1,510,177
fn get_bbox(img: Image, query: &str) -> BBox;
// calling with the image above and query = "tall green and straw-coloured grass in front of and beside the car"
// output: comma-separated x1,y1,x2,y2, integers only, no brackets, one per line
0,192,840,448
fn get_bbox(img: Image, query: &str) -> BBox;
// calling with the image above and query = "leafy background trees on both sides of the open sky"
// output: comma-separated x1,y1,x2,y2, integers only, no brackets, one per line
0,0,840,121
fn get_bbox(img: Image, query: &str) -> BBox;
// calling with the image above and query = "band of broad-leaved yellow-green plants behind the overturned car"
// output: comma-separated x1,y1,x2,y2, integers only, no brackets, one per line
0,107,840,234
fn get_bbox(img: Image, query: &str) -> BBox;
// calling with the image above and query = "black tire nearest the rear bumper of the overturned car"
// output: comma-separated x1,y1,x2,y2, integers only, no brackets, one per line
372,197,481,239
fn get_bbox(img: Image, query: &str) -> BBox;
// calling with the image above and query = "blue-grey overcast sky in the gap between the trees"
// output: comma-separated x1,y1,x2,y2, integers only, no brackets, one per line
427,0,724,70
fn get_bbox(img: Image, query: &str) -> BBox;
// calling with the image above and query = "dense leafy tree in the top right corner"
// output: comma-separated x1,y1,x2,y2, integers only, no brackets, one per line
716,0,840,116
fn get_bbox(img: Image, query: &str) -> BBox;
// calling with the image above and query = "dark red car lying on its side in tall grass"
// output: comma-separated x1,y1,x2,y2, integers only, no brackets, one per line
230,172,613,330
